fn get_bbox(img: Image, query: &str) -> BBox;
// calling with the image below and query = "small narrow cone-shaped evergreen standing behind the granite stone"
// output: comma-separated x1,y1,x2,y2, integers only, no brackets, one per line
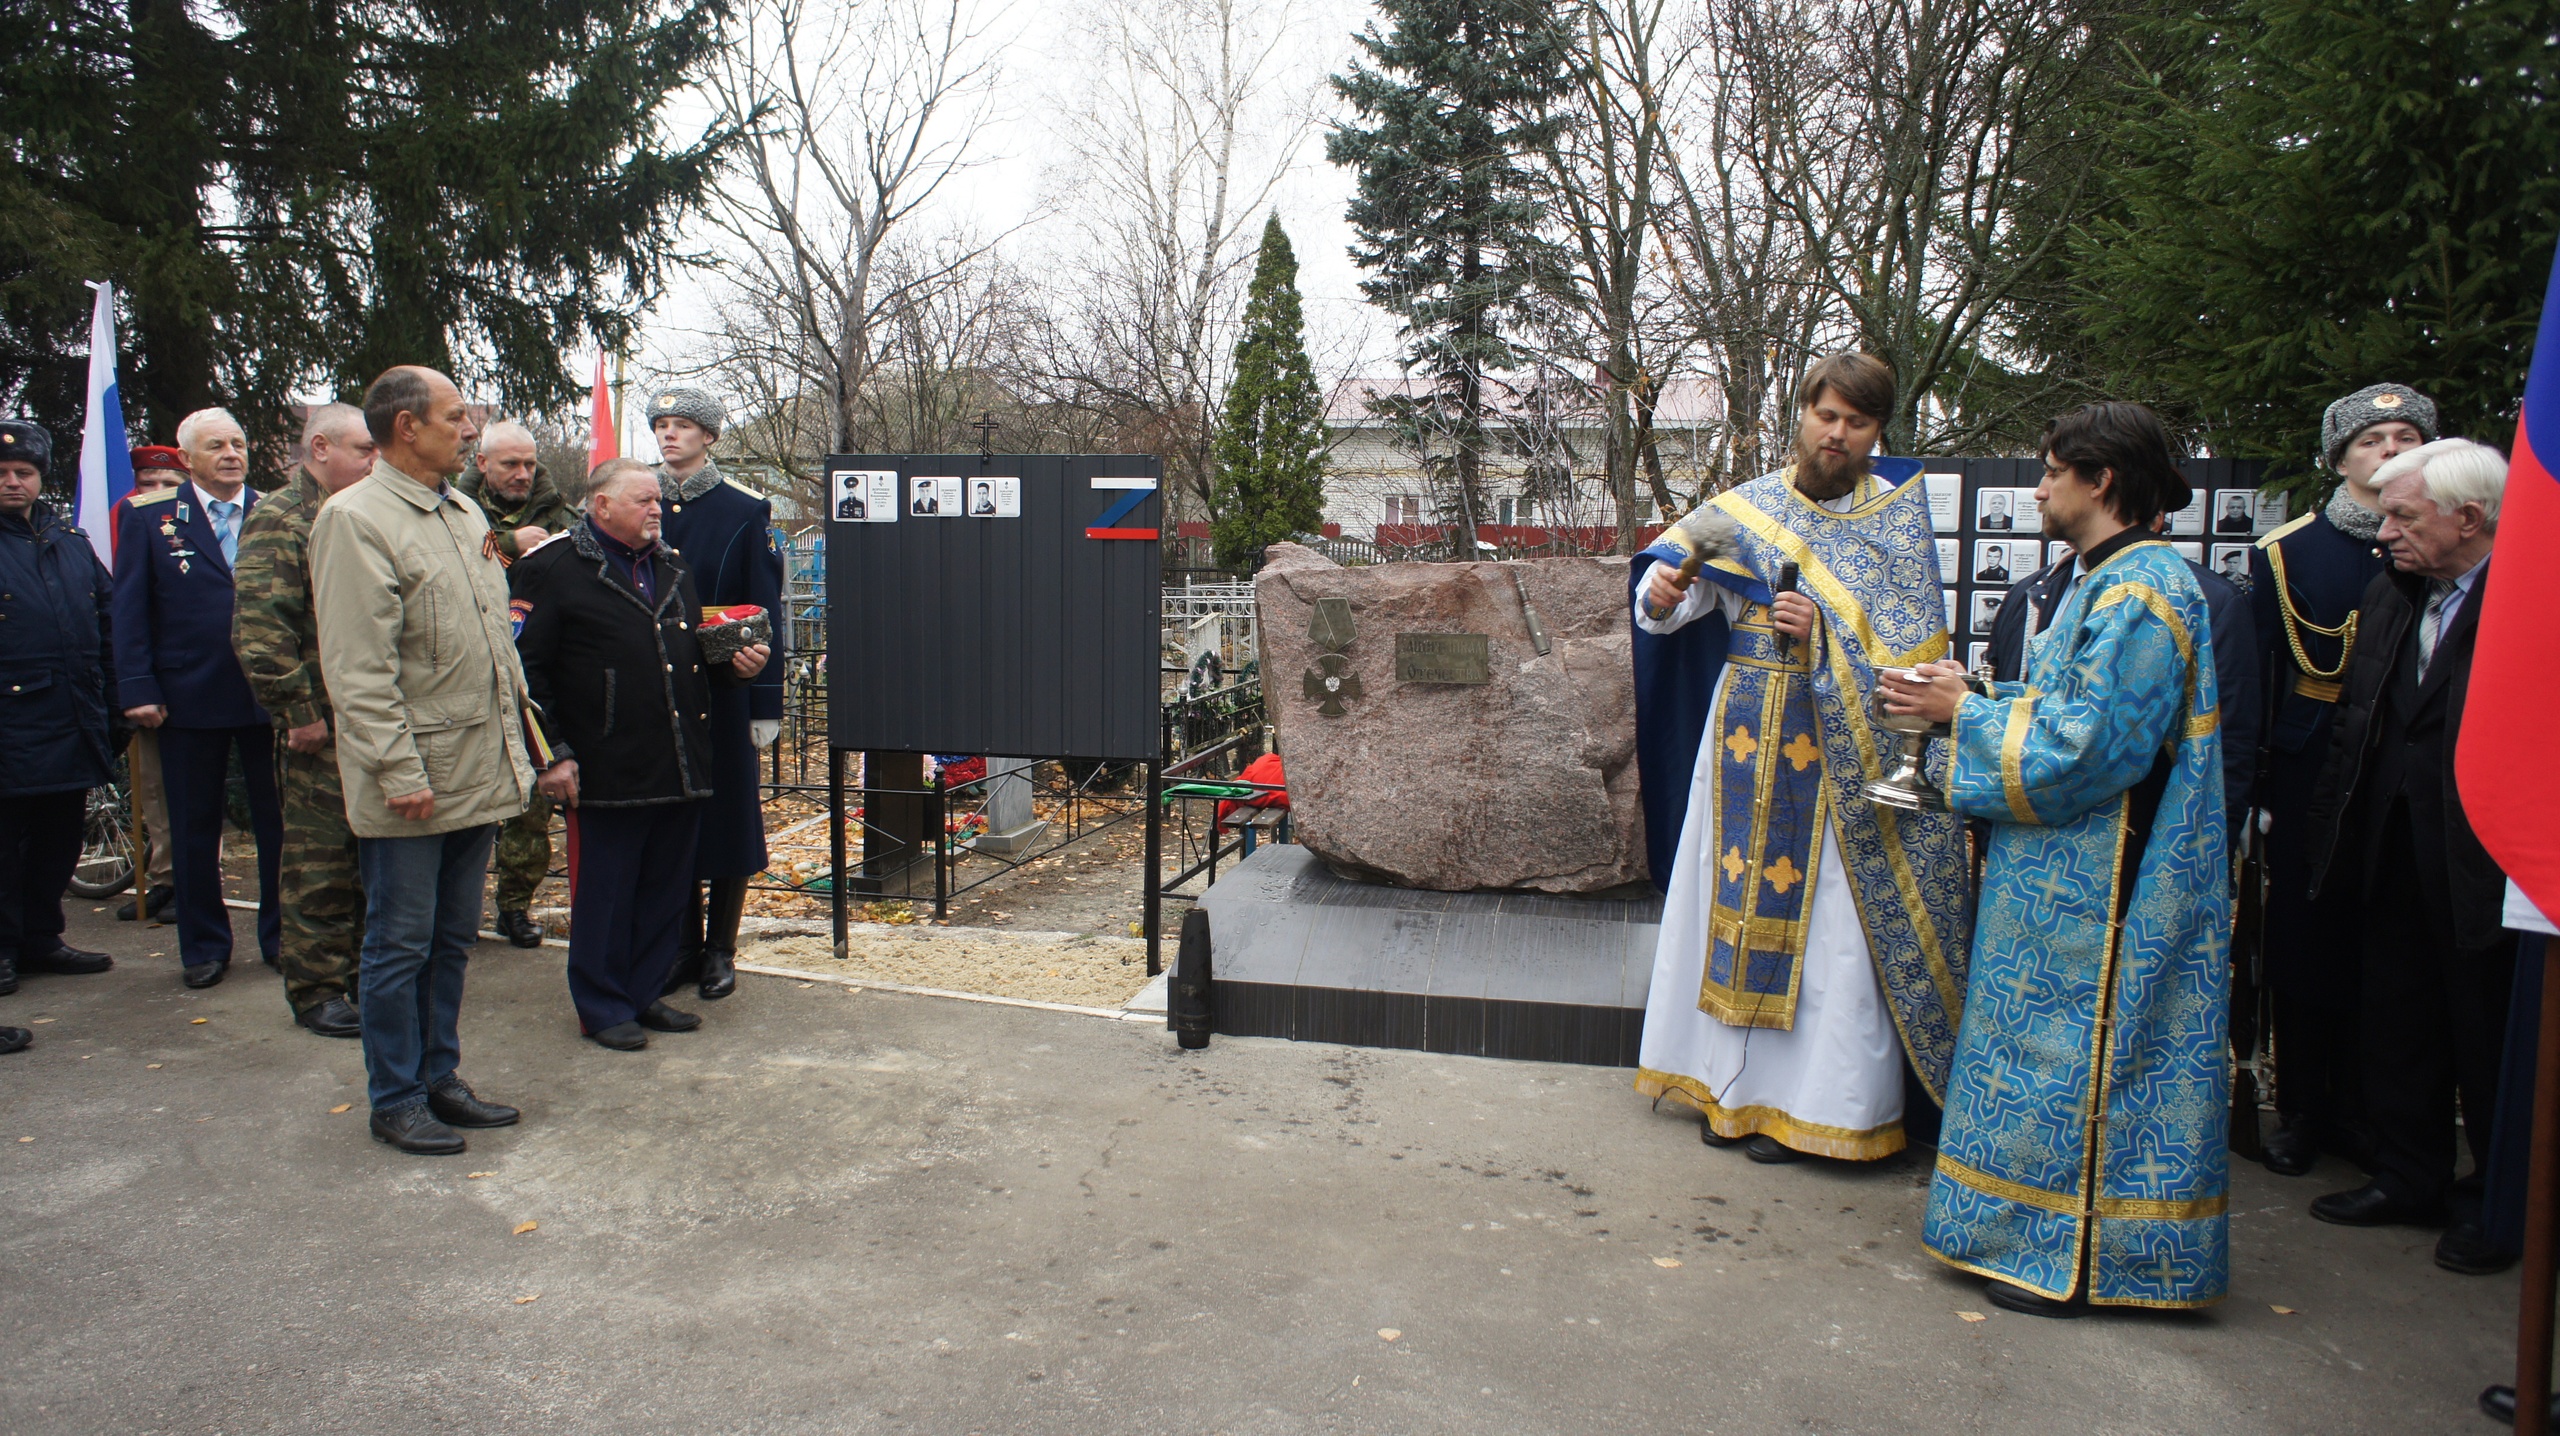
1208,215,1324,571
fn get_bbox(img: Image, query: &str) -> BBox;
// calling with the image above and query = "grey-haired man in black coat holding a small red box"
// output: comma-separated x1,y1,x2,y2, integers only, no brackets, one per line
507,458,771,1052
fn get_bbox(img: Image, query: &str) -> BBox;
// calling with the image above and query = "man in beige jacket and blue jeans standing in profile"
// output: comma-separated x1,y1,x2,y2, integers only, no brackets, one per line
312,366,532,1157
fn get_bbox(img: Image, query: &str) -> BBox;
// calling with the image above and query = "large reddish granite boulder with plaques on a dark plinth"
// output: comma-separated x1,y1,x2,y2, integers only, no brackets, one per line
1254,543,1646,893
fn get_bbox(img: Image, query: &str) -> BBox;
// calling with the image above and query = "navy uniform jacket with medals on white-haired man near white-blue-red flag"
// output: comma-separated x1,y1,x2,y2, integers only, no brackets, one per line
115,481,266,727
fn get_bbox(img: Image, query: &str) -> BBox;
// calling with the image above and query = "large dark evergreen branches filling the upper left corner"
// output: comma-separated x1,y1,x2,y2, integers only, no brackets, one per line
0,0,730,440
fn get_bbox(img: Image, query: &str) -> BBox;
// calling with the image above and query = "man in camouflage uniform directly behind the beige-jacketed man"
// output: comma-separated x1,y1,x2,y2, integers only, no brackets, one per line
230,404,374,1037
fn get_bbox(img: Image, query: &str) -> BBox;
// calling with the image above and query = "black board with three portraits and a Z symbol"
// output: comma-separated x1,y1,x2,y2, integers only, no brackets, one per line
824,453,1165,763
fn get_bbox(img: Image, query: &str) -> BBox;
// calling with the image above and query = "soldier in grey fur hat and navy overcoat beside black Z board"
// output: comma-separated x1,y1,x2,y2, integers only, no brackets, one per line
648,389,786,1001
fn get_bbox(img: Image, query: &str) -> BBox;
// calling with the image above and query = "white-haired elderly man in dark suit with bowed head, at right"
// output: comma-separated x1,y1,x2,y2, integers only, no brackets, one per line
2304,438,2516,1275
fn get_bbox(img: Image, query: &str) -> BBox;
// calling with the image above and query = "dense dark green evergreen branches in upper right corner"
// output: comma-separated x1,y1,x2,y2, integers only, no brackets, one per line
2074,0,2560,486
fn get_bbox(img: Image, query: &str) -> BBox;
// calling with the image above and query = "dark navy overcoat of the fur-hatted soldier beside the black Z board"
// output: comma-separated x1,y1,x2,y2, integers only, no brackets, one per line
658,463,788,878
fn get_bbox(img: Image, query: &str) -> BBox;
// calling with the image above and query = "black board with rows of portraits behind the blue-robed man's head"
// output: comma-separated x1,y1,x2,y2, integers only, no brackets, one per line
1917,458,2284,668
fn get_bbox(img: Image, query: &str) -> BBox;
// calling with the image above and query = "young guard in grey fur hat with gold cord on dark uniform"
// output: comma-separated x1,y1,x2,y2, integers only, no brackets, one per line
2225,384,2435,1177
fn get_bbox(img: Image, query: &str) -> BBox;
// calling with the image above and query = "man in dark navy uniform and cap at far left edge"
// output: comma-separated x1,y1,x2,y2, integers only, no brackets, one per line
0,420,115,1052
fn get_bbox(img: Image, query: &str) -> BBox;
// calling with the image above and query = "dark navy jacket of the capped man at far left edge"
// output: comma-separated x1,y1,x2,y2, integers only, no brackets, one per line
0,502,123,799
